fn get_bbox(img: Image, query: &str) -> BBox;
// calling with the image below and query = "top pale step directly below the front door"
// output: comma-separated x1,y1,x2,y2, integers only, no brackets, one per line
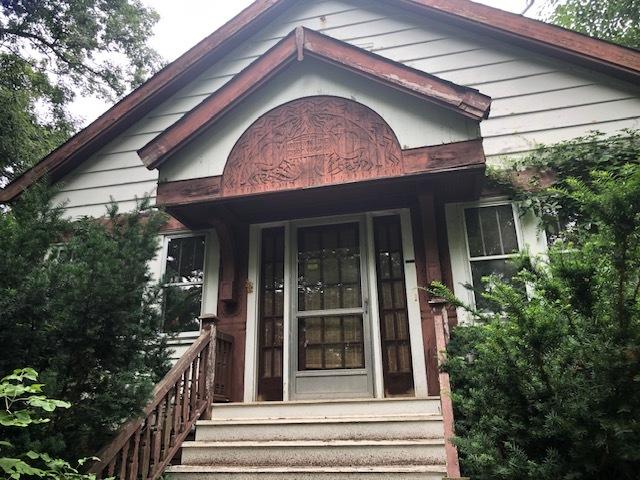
211,397,440,420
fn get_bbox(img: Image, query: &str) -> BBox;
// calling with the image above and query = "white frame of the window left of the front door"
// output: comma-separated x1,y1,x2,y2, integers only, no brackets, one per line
159,230,218,339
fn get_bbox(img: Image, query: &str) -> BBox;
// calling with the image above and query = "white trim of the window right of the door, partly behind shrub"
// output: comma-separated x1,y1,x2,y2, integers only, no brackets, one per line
445,197,547,323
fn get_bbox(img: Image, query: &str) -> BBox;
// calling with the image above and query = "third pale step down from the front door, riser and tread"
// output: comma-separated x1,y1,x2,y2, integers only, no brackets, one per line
182,439,445,467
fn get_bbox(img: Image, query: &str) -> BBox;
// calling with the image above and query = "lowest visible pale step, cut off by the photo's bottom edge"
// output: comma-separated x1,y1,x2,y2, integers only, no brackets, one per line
167,465,446,480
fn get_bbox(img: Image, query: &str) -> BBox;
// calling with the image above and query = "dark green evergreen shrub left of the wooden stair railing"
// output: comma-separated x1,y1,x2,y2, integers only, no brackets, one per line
0,187,168,458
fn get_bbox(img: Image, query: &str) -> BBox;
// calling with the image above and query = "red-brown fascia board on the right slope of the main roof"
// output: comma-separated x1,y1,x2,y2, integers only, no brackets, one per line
394,0,640,80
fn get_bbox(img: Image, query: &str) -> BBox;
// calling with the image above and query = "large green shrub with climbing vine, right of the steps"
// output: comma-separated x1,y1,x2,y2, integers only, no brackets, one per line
434,132,640,480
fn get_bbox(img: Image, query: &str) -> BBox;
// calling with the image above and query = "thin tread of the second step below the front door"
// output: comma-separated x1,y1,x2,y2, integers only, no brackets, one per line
197,413,442,426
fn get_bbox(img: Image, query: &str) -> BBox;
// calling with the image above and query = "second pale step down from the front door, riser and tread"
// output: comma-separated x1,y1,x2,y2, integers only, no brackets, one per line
196,414,444,442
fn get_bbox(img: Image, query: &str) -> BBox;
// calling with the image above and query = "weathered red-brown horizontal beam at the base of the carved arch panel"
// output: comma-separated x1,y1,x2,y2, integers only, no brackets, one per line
156,139,485,207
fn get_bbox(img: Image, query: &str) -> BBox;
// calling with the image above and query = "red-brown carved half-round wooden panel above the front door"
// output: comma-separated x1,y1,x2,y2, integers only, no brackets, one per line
222,96,403,197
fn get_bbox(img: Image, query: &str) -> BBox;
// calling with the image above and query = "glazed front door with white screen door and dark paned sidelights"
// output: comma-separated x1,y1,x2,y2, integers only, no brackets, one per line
254,211,426,401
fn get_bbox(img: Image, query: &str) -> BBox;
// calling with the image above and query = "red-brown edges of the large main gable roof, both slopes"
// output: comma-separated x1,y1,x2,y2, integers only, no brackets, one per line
0,0,640,202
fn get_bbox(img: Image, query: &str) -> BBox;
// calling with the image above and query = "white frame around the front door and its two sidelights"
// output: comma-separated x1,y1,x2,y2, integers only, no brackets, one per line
244,208,428,402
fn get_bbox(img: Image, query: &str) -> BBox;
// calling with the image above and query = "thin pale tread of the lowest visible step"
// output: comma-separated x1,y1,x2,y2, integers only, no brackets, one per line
166,464,446,473
